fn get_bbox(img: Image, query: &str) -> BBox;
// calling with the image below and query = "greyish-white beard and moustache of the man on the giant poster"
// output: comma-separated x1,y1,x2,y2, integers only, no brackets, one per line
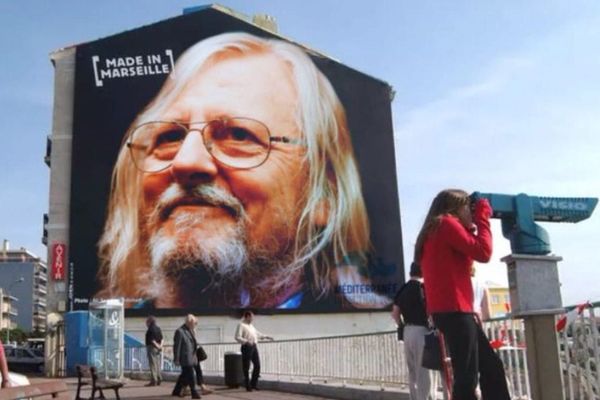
140,184,300,304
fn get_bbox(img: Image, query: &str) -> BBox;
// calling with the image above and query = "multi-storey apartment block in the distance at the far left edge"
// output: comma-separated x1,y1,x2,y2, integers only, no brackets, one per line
0,240,48,332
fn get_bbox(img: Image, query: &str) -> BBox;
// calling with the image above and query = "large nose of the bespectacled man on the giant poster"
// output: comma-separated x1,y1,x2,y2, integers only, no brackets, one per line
171,130,218,187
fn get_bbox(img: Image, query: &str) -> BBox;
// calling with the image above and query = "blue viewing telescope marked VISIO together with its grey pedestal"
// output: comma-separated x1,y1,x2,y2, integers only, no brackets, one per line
471,192,598,400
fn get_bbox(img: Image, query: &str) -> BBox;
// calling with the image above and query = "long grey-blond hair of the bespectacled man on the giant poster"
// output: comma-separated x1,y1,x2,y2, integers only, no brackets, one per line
99,33,378,306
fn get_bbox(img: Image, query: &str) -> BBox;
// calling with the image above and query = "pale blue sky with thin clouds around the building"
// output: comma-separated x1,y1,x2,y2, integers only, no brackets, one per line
0,0,600,305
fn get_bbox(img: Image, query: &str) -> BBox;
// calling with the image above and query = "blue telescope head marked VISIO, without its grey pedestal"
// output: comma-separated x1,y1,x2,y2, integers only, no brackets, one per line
471,192,598,255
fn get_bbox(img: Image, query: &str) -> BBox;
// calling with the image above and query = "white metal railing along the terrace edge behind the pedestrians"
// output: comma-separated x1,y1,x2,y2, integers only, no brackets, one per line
125,302,600,400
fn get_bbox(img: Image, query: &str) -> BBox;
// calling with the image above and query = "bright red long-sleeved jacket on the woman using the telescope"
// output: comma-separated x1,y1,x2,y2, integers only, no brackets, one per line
421,201,492,314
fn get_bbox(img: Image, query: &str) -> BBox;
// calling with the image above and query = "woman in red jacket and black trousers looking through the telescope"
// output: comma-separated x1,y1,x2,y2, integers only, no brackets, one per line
415,189,510,400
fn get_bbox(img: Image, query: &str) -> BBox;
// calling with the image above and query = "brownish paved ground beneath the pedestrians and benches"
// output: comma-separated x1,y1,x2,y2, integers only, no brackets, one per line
30,378,338,400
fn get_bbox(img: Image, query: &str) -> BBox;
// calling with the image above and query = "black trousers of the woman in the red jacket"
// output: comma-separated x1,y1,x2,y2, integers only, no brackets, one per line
433,313,510,400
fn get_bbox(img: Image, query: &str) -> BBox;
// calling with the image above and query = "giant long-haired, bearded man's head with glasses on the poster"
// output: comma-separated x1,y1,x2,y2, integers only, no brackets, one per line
99,33,390,309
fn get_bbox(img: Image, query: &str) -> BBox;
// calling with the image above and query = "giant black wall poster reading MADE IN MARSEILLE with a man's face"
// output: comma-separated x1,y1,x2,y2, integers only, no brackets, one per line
69,4,404,315
